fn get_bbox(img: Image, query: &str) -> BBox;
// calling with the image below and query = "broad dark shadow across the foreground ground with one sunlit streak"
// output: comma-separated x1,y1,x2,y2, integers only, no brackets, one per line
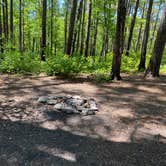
0,120,166,166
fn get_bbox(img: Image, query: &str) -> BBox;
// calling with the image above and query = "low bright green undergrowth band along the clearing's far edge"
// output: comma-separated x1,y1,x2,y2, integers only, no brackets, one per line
0,51,166,77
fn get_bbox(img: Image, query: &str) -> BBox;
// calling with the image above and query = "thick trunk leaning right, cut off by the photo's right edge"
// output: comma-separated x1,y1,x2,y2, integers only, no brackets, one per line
145,5,166,77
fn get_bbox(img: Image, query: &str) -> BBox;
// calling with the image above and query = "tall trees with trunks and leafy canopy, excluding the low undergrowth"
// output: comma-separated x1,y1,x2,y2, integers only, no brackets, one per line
0,0,166,80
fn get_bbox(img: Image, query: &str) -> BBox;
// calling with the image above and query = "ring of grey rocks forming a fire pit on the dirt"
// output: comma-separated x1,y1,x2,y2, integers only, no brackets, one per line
38,95,98,116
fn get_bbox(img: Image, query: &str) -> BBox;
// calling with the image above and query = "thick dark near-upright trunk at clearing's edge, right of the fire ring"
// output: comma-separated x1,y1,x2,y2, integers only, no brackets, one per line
111,0,127,80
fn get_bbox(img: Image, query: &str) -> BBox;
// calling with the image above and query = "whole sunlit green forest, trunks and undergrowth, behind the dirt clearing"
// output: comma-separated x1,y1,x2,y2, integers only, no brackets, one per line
0,0,166,79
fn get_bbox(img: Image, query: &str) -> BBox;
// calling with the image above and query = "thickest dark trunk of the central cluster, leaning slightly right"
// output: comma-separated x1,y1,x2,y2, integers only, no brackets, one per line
66,0,77,55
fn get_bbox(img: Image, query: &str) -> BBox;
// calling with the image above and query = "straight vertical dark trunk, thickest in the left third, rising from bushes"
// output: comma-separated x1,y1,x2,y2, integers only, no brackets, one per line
41,0,47,61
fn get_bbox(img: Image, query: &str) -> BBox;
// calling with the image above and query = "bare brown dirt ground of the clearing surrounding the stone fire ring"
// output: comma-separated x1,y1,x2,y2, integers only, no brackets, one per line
0,75,166,166
